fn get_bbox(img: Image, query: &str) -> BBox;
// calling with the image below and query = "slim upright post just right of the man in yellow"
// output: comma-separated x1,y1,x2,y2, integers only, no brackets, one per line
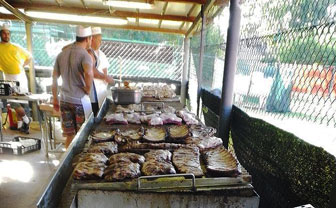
25,22,38,121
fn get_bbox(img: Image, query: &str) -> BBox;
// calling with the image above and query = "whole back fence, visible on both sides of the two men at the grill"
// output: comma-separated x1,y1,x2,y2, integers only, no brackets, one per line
1,21,183,90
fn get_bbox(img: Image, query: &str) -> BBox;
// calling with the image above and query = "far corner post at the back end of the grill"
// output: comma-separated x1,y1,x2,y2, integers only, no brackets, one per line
180,37,190,106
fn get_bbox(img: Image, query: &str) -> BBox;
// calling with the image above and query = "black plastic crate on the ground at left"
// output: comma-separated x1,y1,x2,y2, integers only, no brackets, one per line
0,136,41,155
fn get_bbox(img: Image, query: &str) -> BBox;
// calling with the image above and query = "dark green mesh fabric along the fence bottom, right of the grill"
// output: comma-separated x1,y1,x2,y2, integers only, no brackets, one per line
231,107,336,207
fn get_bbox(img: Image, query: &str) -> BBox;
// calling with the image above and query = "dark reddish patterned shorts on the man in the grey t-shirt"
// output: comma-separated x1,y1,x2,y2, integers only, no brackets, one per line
60,101,85,136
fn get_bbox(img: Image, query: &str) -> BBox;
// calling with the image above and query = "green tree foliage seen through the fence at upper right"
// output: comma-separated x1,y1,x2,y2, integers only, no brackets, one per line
255,0,336,65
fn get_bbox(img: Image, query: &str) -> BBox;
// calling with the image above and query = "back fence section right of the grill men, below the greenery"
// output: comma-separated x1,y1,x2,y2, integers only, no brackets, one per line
101,41,183,82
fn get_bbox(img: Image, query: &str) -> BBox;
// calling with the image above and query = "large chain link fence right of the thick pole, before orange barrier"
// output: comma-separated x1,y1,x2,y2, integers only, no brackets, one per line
234,0,336,127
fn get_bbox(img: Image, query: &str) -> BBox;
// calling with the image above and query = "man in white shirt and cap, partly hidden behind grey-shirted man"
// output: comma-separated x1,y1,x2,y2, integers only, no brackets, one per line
88,27,114,116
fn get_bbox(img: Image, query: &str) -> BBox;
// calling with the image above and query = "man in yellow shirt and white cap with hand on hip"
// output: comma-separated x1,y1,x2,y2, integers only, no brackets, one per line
0,24,32,134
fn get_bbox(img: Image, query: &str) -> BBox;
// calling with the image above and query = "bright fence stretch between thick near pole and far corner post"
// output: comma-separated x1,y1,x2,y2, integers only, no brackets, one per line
188,4,229,113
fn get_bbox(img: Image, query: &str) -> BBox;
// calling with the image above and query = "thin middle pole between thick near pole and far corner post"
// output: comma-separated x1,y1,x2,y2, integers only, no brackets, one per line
196,6,206,116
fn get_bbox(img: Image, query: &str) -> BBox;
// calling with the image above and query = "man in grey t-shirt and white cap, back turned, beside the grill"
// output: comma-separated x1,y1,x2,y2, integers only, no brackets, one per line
52,26,93,147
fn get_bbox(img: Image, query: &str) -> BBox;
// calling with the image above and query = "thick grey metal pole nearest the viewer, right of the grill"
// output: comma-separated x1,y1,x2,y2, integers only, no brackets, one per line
218,0,241,147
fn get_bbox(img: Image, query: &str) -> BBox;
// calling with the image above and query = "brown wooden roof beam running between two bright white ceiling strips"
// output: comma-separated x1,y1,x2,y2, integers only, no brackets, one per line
12,3,195,22
